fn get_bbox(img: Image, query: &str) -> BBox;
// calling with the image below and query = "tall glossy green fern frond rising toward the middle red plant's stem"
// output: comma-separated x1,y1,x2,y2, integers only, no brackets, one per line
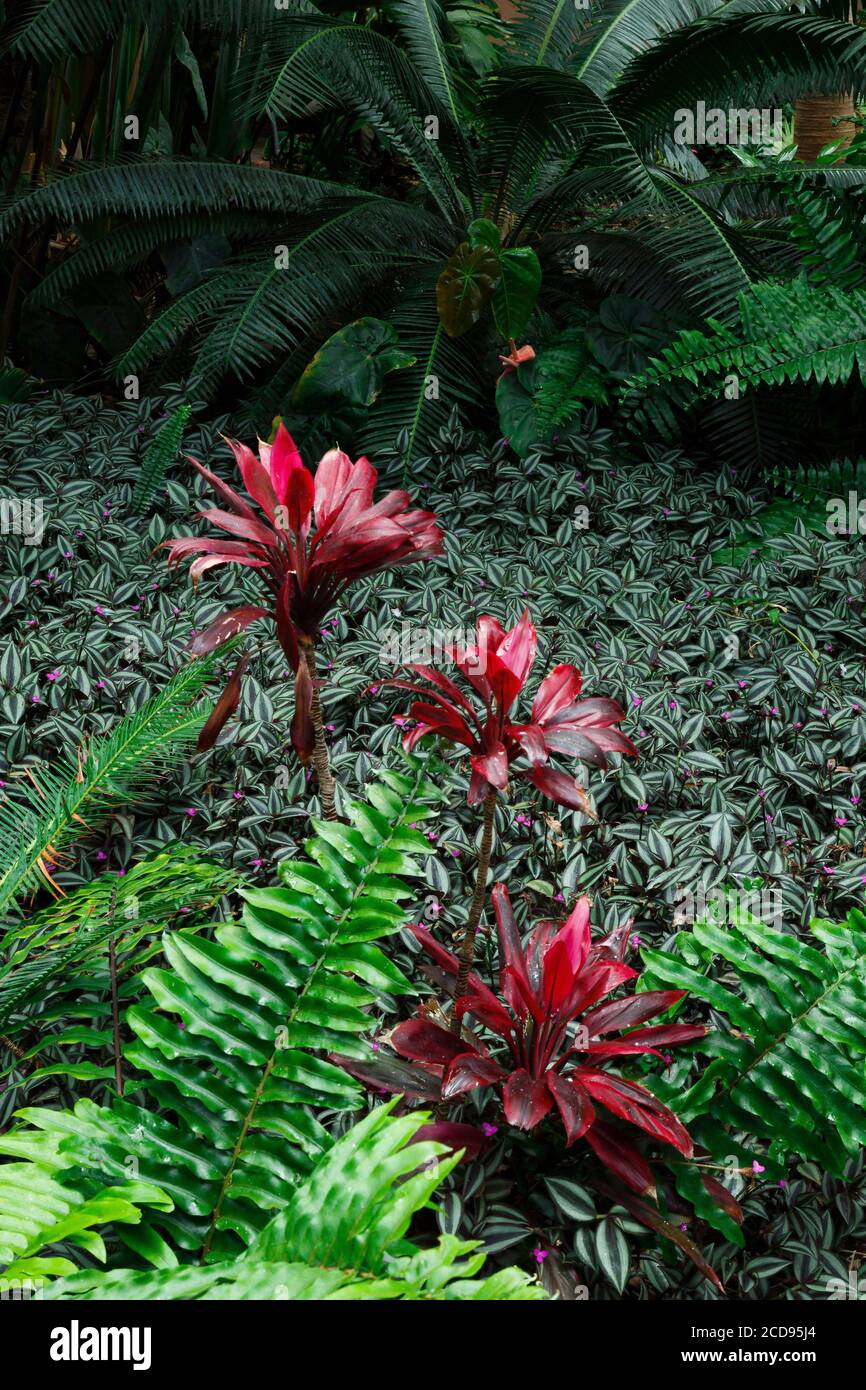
0,759,442,1265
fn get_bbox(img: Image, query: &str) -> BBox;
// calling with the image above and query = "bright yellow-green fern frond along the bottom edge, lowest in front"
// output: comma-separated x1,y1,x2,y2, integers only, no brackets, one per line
35,1102,545,1302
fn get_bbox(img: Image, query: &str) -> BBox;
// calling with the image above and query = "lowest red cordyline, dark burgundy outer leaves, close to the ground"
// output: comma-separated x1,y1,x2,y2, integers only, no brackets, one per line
341,883,706,1195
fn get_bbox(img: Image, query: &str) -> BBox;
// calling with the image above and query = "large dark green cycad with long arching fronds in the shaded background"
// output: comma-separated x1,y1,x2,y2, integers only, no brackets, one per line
6,0,865,459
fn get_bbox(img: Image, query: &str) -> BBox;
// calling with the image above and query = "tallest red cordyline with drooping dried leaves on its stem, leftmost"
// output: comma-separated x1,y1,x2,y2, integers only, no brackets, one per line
163,424,442,819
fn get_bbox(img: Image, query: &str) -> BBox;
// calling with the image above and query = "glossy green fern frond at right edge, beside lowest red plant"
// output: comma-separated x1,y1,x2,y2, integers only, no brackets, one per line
642,909,866,1179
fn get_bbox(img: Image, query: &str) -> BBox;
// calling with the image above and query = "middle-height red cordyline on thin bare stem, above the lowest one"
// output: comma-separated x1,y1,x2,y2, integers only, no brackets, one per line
384,609,637,1031
